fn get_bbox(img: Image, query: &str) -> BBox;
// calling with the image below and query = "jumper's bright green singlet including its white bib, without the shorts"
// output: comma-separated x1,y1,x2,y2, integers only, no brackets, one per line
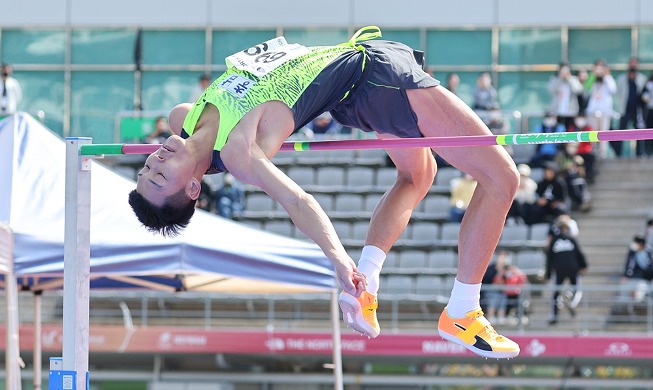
183,28,380,166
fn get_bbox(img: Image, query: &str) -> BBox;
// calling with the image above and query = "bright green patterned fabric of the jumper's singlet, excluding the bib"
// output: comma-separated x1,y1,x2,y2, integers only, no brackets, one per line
183,26,381,151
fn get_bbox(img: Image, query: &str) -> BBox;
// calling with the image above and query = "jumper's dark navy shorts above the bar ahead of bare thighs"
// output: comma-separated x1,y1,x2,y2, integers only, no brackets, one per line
330,40,440,138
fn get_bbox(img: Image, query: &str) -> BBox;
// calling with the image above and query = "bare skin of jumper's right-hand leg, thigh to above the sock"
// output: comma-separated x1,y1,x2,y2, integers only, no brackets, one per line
408,87,519,284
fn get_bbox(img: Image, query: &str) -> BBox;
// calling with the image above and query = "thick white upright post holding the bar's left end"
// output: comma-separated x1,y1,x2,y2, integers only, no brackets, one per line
62,137,92,390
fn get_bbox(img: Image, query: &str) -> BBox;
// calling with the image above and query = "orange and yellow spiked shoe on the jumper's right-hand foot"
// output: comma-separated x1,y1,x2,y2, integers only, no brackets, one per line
438,307,519,359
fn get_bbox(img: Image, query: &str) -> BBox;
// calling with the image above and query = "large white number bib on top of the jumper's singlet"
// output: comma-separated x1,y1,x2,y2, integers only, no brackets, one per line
225,37,310,77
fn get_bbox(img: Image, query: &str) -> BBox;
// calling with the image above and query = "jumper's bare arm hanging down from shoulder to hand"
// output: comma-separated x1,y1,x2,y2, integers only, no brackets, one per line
220,125,365,296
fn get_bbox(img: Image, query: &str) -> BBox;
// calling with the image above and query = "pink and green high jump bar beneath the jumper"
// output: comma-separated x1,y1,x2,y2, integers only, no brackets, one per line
80,129,653,156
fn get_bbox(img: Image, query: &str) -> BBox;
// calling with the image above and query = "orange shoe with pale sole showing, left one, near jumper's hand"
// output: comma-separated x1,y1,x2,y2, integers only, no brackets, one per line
338,291,381,338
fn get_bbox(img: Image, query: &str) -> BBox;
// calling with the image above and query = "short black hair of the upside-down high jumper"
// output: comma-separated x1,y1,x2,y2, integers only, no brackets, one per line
129,190,195,237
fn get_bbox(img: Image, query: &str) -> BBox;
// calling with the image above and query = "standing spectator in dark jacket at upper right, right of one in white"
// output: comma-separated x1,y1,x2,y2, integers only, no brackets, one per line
610,57,646,156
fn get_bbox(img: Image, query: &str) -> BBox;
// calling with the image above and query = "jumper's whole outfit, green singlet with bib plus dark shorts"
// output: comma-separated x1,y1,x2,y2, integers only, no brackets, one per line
181,26,439,174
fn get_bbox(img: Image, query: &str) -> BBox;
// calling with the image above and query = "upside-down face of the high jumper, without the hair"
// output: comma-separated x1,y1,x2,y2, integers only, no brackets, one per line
136,135,195,206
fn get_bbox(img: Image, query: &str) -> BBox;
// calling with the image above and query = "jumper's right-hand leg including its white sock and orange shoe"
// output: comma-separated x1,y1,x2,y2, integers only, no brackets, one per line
408,86,519,358
